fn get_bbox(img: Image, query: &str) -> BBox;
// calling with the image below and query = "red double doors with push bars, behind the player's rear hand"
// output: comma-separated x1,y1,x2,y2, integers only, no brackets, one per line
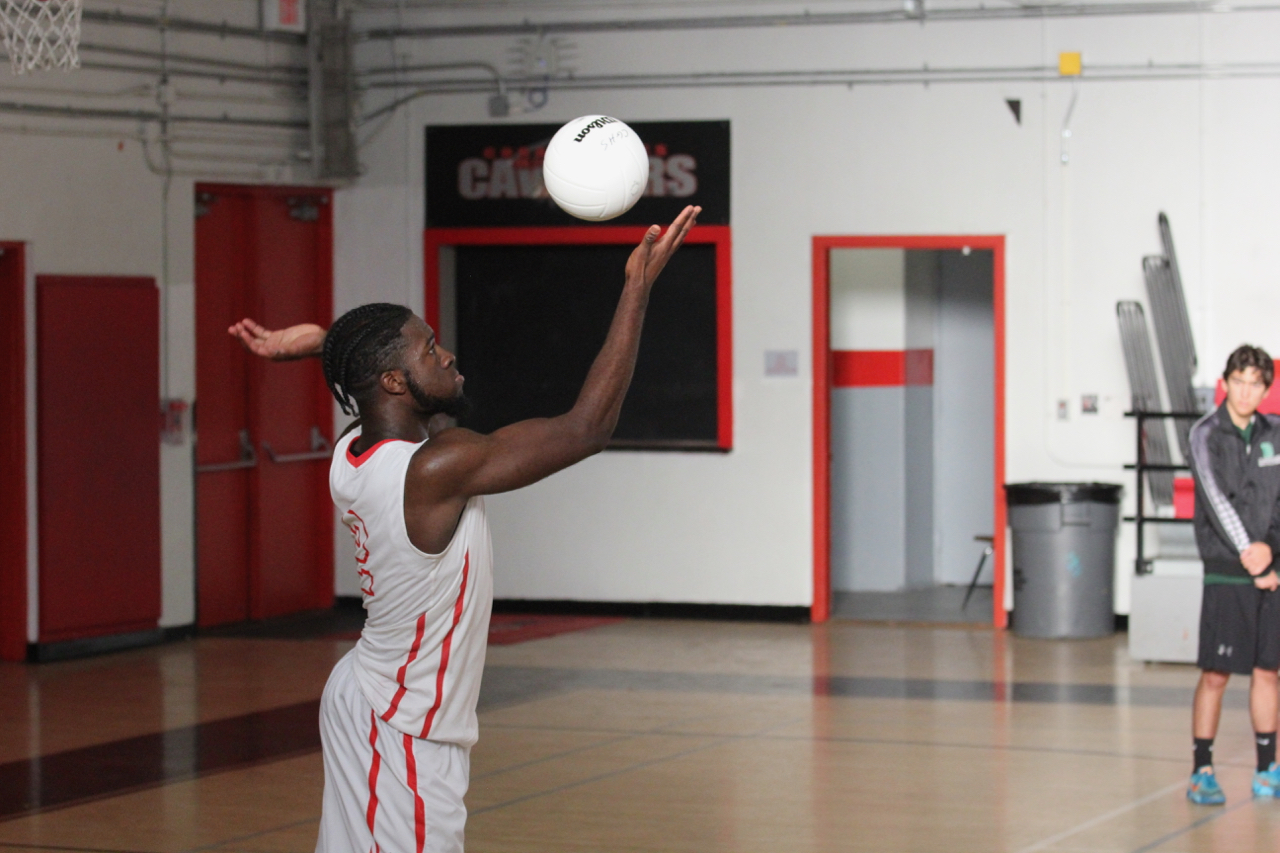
196,184,333,625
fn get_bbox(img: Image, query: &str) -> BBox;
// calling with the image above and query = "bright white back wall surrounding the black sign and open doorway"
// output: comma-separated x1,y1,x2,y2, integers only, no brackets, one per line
343,4,1280,610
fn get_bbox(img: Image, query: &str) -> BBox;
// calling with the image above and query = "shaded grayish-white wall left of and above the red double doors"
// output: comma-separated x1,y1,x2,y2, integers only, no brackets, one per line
0,0,306,630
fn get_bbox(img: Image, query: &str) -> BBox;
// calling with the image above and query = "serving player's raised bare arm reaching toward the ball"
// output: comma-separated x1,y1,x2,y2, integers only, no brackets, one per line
411,206,701,503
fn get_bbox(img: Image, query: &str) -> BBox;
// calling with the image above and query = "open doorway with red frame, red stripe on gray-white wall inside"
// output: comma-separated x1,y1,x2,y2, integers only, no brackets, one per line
813,237,1006,626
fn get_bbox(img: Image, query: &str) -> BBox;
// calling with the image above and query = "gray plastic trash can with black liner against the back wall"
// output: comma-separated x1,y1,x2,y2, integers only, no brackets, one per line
1005,483,1120,638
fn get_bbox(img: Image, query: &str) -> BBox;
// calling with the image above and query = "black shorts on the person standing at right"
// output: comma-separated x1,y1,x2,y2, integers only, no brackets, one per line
1196,583,1280,675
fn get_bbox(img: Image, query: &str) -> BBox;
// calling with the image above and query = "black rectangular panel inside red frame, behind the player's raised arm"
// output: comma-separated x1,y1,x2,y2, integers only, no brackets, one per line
456,245,719,450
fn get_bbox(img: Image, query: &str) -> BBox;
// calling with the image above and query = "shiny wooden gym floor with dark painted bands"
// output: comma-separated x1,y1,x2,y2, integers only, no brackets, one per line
0,620,1280,853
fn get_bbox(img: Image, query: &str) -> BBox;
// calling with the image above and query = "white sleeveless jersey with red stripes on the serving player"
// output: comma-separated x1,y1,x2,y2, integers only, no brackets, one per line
329,429,493,747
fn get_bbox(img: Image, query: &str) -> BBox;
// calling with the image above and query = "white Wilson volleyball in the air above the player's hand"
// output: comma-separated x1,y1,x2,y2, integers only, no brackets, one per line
543,115,649,222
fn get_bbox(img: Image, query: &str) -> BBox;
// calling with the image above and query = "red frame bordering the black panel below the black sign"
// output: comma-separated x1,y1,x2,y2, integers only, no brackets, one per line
422,225,733,451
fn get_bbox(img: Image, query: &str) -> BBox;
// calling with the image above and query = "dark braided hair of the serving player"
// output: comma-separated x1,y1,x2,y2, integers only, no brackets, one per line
320,302,413,415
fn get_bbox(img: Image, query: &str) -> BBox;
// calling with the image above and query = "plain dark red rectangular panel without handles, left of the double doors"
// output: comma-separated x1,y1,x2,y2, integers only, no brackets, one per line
36,275,160,643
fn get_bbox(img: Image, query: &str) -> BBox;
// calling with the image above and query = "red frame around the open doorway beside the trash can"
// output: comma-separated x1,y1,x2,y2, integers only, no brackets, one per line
810,234,1009,628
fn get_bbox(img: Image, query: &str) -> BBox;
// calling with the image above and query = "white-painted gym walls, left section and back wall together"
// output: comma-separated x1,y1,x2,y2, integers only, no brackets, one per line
0,0,1280,624
